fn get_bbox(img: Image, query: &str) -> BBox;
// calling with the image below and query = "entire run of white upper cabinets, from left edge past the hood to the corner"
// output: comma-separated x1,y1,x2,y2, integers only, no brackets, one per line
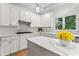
0,3,51,27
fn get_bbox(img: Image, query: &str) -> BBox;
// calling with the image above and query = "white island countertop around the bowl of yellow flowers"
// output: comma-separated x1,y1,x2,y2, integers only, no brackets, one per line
27,36,79,56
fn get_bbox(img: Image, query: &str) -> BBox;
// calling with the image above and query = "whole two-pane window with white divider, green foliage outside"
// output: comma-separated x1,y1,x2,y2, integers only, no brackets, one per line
56,15,76,30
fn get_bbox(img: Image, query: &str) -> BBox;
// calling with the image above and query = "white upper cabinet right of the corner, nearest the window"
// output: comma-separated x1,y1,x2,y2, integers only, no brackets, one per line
40,13,51,27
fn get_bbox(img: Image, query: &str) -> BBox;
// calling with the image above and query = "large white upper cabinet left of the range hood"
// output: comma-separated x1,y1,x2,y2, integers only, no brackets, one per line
0,3,19,26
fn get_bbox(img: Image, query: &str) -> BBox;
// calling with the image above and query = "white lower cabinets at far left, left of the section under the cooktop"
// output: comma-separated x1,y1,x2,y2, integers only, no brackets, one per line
0,36,20,56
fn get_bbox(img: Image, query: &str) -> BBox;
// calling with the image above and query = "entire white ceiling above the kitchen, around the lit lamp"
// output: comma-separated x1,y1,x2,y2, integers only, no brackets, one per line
11,3,77,14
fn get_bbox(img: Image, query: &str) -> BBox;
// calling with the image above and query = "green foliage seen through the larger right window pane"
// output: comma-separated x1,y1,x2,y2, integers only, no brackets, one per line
65,15,76,29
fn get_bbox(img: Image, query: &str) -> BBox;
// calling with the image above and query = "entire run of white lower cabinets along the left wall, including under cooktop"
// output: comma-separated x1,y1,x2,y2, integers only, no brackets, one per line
0,34,29,56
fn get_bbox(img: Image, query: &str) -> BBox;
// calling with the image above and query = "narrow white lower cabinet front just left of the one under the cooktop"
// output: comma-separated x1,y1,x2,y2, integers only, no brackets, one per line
11,36,19,53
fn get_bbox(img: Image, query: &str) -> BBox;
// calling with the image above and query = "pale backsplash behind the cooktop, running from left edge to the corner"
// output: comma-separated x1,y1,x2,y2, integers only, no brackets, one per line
0,25,38,35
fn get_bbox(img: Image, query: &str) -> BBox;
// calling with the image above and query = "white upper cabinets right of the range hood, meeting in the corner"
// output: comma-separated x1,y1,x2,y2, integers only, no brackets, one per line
31,13,51,27
